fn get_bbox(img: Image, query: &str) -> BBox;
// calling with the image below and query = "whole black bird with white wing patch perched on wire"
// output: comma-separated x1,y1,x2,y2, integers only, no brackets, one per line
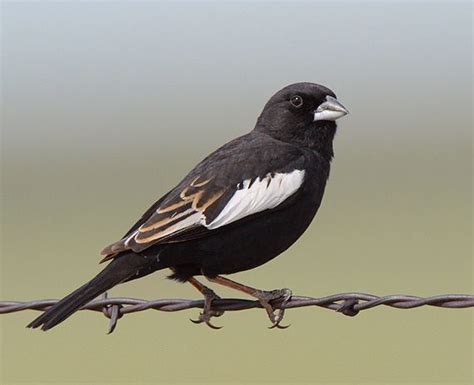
28,83,348,330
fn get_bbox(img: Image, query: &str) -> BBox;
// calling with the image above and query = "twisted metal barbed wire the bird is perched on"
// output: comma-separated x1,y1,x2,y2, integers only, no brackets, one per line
0,293,474,333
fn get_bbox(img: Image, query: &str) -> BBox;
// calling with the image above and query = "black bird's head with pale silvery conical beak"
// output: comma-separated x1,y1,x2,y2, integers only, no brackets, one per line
255,83,349,159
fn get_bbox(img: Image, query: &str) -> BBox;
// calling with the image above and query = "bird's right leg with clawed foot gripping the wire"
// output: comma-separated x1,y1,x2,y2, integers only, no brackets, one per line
206,275,292,329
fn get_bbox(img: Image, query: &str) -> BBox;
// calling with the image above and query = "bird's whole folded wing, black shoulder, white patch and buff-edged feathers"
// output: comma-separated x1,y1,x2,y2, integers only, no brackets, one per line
102,134,305,260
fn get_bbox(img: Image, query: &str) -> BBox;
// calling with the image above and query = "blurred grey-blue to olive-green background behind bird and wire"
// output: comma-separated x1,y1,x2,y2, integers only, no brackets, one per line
0,1,473,384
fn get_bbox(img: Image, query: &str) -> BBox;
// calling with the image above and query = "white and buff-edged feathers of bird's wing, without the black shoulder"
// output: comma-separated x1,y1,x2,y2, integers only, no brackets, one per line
102,170,305,259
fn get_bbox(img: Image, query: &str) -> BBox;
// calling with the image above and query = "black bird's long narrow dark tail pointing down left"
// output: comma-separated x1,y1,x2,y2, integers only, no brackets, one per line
27,253,156,330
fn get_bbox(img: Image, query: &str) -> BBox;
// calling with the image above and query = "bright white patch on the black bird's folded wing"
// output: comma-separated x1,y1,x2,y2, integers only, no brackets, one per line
206,170,304,230
